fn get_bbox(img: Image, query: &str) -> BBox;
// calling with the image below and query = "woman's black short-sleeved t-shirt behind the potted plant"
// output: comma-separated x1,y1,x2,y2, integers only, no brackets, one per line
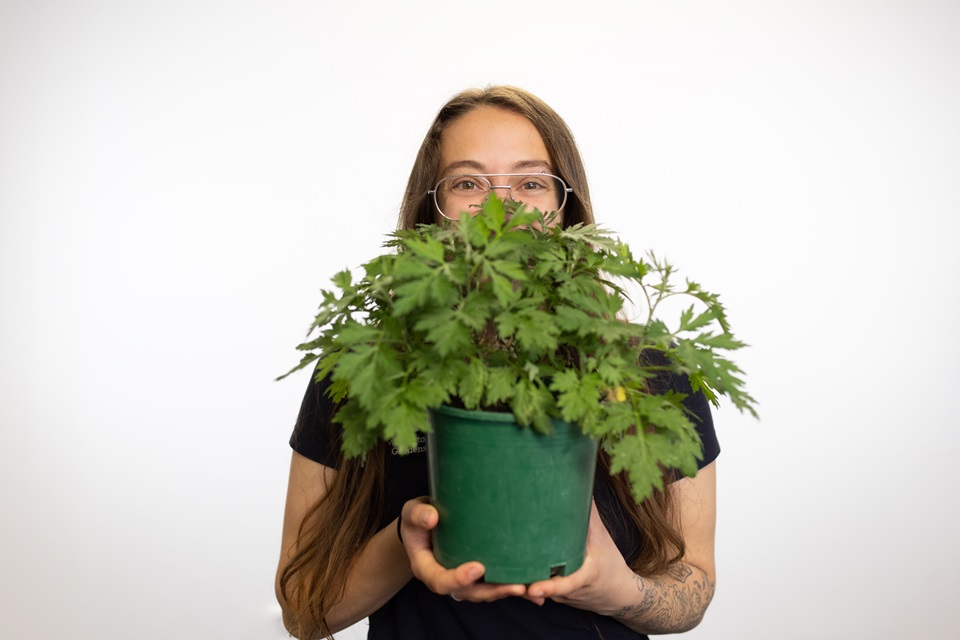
290,364,720,640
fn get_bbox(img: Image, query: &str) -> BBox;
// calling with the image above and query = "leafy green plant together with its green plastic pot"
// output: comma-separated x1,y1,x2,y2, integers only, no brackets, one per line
278,196,755,582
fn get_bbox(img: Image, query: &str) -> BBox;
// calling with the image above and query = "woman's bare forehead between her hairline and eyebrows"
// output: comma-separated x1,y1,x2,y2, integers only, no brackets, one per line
440,105,550,173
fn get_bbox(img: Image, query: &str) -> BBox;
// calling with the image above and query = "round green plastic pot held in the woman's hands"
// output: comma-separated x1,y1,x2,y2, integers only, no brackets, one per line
427,407,597,584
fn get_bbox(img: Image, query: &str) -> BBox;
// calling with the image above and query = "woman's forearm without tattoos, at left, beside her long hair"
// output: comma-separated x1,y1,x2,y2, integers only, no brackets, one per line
278,522,413,640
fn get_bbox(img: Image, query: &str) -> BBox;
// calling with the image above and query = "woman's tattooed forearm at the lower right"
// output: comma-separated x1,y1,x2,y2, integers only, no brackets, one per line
613,562,716,633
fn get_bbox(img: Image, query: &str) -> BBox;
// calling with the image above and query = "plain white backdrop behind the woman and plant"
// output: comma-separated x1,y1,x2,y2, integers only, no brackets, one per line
0,0,960,640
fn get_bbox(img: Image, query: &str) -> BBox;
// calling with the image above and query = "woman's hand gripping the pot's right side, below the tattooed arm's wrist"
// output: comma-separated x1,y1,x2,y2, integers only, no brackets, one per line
524,502,635,614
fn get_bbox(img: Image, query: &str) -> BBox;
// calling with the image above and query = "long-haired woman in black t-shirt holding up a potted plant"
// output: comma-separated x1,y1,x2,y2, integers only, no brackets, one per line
277,87,719,640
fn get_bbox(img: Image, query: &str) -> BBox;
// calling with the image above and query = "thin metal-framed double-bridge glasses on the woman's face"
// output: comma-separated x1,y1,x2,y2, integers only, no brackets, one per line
433,173,567,220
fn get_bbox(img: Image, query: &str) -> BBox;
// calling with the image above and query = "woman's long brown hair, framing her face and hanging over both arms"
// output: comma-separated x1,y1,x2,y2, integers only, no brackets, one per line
280,86,684,637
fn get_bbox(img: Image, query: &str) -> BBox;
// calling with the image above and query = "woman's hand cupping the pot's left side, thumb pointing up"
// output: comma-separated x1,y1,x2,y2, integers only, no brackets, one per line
400,497,527,602
